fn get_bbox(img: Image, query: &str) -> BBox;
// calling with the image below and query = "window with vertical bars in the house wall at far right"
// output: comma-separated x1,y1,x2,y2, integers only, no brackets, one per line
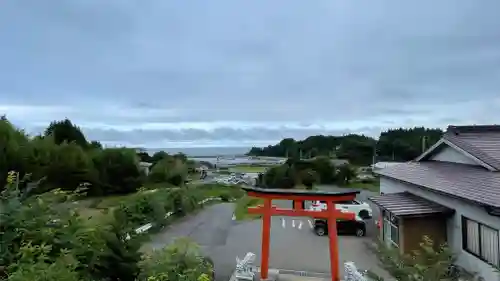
462,217,500,266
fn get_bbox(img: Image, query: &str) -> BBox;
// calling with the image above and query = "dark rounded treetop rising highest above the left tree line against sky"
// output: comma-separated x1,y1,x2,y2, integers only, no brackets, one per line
45,119,88,148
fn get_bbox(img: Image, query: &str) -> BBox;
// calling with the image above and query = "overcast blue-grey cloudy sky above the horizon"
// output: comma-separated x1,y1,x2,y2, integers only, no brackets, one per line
0,0,500,147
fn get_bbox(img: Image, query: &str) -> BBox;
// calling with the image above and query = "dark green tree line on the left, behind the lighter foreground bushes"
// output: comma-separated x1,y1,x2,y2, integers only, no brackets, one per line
0,117,196,196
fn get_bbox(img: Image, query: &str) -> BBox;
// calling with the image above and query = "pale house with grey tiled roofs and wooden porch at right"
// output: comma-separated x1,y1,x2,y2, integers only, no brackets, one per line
370,126,500,281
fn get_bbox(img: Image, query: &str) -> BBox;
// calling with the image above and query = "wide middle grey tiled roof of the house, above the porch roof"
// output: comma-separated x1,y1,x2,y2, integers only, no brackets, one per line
377,161,500,207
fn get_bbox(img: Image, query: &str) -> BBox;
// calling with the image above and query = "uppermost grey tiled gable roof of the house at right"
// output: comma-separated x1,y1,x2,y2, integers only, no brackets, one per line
443,125,500,170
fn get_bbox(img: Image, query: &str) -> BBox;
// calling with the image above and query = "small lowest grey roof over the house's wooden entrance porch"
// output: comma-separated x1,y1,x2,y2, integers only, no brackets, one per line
368,192,453,216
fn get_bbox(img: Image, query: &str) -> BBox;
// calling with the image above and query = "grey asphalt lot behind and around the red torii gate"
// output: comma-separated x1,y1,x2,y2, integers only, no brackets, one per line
145,190,385,281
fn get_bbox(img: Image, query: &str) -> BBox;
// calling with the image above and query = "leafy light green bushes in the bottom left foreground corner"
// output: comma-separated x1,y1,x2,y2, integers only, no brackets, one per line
0,180,139,281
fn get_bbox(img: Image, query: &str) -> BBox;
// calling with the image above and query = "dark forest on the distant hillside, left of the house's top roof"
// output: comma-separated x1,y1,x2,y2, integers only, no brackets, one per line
247,127,443,165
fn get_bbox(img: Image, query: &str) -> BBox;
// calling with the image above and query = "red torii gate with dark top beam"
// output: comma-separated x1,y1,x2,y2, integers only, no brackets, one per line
243,187,359,281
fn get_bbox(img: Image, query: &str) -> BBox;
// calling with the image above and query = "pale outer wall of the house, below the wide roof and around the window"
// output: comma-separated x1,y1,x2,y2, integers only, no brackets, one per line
380,177,500,281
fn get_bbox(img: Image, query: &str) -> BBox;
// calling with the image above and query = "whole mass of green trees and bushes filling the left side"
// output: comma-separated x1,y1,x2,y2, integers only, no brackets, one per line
0,117,236,281
